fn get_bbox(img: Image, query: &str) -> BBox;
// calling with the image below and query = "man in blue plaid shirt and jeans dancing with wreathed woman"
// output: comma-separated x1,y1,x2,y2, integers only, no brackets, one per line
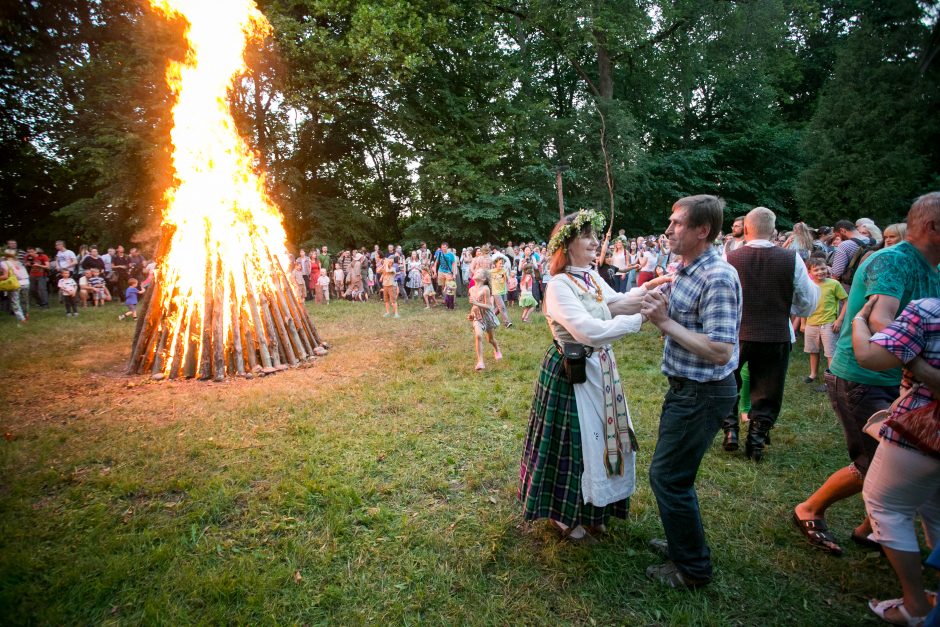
642,195,742,588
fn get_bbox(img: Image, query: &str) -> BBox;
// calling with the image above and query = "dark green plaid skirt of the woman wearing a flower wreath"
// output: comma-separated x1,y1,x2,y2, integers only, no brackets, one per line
519,346,630,527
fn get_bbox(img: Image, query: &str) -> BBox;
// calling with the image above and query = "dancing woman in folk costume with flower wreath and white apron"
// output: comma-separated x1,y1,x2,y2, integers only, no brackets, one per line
519,210,646,541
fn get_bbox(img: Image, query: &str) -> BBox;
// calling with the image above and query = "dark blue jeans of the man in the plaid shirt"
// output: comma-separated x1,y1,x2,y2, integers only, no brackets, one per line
650,374,738,581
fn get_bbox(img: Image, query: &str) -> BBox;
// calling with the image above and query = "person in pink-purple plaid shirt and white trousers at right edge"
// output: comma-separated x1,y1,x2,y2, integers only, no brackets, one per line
852,296,940,625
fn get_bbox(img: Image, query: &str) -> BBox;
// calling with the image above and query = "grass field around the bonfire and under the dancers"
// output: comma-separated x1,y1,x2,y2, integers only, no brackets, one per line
0,301,916,625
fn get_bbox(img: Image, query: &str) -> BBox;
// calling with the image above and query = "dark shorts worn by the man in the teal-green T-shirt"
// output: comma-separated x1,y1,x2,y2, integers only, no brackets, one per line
825,371,899,477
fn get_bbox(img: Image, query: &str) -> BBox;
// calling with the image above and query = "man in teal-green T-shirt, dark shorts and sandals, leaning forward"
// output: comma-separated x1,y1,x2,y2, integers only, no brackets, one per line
793,192,940,555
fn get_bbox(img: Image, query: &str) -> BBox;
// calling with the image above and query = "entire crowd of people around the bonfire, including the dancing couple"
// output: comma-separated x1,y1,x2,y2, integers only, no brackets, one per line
0,199,940,625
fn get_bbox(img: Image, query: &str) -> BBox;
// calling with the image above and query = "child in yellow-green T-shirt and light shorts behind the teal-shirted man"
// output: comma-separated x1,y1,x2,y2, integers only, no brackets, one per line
803,257,849,392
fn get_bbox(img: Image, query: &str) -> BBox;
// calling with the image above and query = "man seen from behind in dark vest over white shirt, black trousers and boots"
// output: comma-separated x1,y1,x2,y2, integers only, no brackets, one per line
723,207,819,461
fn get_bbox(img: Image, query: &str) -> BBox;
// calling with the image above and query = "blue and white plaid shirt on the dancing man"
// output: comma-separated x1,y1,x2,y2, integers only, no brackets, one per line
663,247,742,383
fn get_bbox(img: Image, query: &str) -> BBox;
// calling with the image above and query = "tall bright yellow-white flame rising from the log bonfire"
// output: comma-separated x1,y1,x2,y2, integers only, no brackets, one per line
135,0,312,378
